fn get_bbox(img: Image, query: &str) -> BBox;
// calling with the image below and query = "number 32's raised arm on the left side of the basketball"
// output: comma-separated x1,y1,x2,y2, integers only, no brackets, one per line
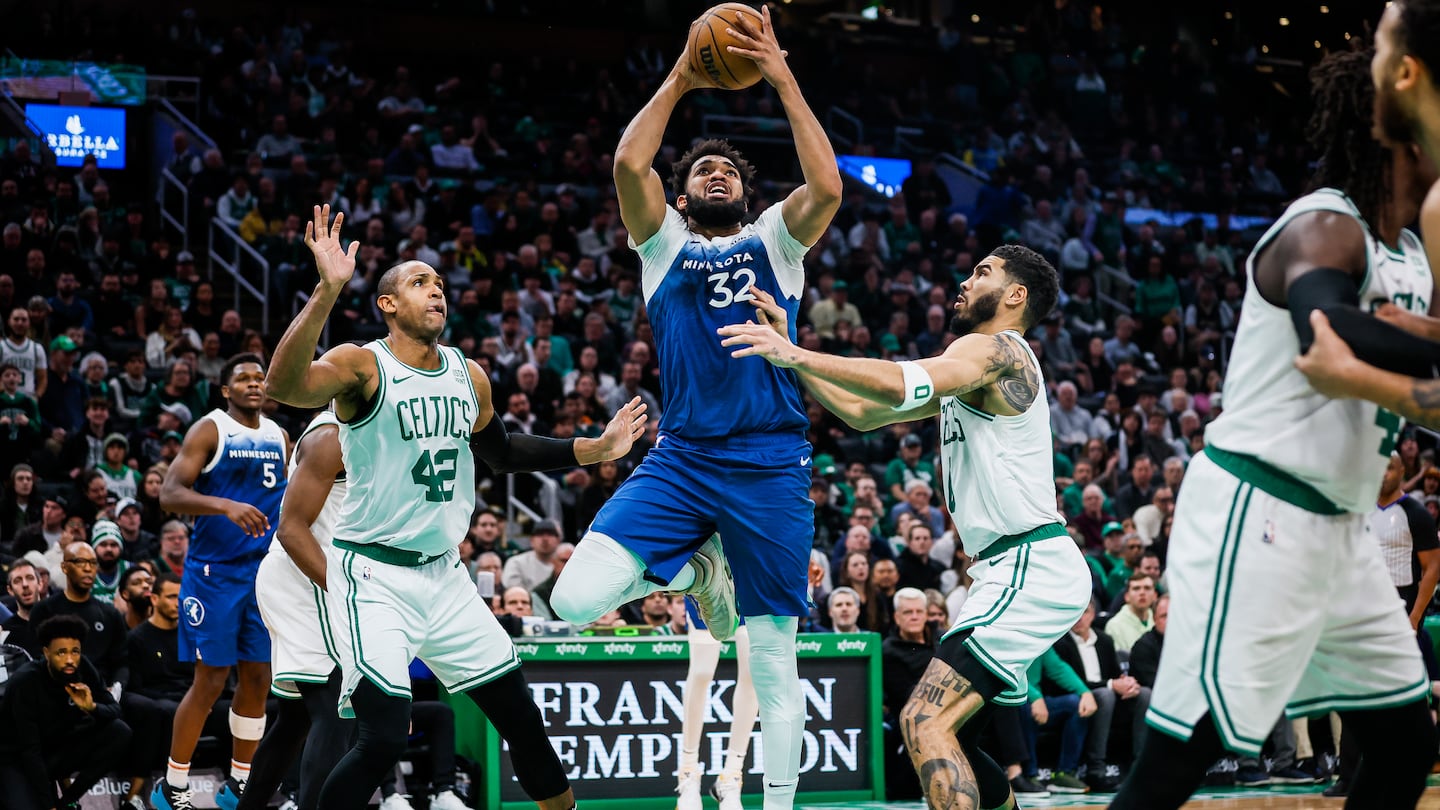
613,42,713,245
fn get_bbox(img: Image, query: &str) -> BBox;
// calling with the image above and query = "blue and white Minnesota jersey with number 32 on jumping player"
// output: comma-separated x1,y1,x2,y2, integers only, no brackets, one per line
631,205,809,441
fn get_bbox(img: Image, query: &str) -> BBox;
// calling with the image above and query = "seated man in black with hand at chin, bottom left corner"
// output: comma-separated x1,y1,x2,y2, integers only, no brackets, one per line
0,615,130,810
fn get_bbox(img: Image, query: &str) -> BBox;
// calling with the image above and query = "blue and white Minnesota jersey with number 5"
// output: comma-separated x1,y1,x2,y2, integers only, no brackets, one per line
186,409,285,564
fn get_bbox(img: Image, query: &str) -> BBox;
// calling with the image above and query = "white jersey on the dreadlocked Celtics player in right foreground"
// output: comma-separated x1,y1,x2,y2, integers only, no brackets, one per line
1205,189,1434,513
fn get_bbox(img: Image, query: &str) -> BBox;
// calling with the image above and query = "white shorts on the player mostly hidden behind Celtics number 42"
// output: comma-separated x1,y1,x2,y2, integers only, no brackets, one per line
255,551,337,699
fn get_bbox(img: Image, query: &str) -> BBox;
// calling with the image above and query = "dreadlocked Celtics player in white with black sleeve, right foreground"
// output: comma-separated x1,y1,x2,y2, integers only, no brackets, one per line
1112,52,1440,810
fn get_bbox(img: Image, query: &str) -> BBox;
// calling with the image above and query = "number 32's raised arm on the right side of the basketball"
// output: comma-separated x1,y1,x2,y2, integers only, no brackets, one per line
730,6,844,245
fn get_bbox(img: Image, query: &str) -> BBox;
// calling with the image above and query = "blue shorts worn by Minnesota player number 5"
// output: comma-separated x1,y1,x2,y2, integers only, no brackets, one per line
179,555,271,666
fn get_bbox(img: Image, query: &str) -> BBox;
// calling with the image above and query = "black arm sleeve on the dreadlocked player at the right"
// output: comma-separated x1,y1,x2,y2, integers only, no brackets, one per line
1286,267,1440,379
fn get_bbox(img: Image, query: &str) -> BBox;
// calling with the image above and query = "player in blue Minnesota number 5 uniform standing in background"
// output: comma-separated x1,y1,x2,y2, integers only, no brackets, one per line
150,355,285,810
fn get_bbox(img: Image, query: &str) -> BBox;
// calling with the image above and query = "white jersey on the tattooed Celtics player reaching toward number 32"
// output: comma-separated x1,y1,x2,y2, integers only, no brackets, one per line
940,331,1064,558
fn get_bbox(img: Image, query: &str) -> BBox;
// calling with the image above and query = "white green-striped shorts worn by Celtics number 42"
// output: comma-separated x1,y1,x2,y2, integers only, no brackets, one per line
325,548,520,718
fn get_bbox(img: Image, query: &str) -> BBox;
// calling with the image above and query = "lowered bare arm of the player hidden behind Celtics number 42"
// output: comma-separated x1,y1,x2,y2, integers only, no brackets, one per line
275,425,346,589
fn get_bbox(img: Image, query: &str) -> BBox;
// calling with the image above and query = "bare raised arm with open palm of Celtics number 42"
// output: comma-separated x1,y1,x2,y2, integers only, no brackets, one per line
265,205,374,408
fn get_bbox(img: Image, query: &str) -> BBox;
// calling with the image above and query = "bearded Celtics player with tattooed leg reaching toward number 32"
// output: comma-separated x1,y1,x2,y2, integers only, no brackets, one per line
719,245,1090,810
